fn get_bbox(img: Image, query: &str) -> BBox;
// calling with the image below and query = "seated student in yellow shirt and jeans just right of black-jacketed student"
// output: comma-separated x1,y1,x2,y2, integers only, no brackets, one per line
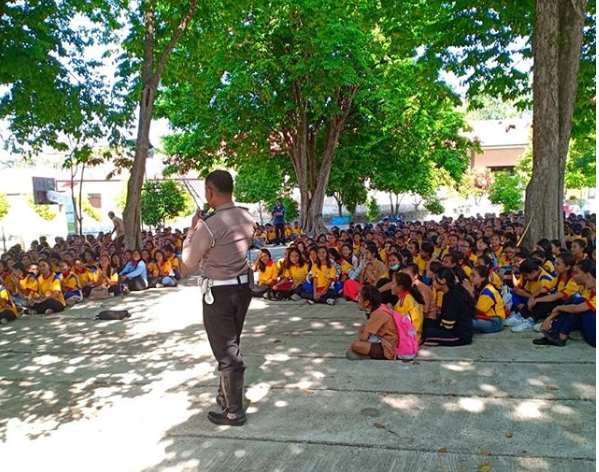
470,265,505,333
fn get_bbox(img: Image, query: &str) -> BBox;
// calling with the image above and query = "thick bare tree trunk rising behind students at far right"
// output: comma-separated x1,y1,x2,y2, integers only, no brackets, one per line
525,0,586,247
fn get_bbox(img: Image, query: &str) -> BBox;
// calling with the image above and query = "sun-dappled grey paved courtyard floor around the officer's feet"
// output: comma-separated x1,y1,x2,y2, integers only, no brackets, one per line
0,280,596,472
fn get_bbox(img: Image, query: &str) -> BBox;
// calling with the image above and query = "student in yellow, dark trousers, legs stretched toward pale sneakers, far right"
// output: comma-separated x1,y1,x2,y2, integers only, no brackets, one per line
512,252,584,333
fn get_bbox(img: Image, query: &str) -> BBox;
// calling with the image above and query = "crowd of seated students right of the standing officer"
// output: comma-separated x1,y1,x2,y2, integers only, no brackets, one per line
253,215,596,359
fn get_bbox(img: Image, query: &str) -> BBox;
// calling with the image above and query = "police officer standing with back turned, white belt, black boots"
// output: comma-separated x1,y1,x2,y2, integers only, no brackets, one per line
182,170,255,426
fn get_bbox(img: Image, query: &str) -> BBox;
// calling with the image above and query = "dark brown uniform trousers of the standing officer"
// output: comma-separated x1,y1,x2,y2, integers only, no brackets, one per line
202,283,252,373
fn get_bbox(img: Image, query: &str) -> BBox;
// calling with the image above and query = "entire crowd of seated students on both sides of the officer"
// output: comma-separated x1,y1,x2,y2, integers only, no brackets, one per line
0,211,596,358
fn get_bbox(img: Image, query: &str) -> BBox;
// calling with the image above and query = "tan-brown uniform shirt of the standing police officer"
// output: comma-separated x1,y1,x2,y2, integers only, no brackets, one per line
181,202,255,280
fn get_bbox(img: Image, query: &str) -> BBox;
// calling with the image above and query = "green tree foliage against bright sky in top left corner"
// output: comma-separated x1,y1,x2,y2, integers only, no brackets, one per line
0,0,127,154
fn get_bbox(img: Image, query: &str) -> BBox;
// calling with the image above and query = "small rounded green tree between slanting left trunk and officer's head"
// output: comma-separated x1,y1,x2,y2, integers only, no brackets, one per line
141,180,189,227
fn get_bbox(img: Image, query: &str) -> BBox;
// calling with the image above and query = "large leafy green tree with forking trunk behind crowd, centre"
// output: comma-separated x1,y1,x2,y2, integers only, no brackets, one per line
160,0,478,231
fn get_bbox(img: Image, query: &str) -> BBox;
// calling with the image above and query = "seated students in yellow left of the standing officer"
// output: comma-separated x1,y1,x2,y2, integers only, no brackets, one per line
0,228,184,323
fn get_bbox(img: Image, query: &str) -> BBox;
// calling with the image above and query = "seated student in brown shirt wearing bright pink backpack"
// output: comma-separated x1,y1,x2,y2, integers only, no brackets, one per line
346,285,418,360
